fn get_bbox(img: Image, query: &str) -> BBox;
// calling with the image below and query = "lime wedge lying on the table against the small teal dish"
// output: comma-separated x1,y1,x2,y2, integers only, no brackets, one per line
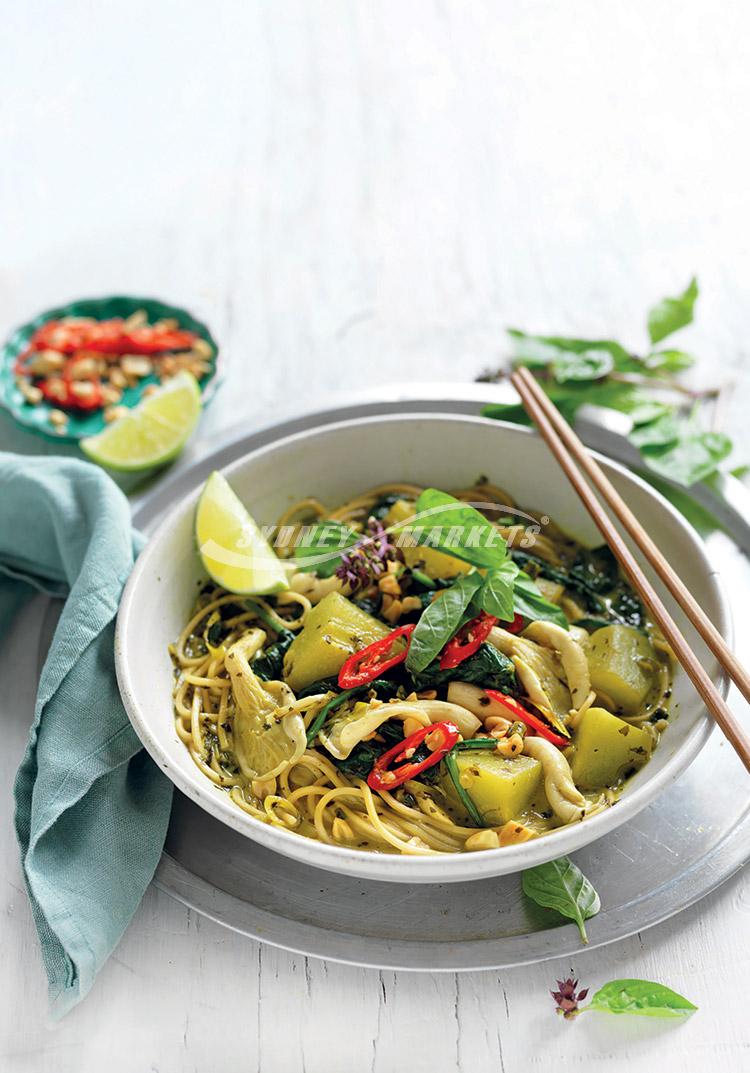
80,371,201,473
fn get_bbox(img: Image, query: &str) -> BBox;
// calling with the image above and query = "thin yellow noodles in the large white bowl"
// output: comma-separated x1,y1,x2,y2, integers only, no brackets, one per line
170,479,672,856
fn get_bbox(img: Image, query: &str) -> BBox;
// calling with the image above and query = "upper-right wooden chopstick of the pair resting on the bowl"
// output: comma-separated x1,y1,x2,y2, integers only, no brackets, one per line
524,369,750,701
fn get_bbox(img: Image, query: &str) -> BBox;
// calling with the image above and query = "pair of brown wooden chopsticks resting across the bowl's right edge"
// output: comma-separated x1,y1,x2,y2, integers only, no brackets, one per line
511,368,750,771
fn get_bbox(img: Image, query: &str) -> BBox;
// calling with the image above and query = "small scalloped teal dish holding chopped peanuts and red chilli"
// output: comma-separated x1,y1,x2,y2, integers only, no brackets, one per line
0,295,219,443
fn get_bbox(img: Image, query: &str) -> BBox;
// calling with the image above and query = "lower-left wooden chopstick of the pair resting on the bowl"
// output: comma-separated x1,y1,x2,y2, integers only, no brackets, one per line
511,368,750,771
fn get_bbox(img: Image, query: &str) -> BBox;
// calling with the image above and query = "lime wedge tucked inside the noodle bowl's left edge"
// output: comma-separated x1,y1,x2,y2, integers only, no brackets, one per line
195,473,289,596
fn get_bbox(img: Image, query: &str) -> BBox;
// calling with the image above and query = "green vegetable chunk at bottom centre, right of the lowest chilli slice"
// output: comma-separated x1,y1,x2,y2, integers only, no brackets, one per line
441,750,546,827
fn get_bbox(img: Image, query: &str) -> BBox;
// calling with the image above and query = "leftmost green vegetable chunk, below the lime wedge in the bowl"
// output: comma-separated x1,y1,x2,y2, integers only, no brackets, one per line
284,592,391,692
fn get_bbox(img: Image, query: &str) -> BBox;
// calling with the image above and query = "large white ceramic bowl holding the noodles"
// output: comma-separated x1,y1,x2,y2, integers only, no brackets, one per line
116,414,730,883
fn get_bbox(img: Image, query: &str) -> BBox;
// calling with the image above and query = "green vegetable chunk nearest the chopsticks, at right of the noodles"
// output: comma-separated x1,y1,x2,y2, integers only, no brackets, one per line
588,626,656,716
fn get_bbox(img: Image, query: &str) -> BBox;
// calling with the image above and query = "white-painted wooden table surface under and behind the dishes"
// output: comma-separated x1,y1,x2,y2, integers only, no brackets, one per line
0,0,750,1073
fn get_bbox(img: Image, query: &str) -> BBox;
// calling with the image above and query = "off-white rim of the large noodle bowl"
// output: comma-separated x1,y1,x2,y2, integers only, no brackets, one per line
115,411,733,883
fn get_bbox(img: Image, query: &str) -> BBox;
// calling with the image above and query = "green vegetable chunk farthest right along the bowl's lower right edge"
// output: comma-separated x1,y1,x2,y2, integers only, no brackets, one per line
571,708,651,790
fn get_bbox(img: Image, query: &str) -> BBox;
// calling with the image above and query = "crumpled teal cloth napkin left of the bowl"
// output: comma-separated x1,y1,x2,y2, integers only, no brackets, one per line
0,453,172,1017
